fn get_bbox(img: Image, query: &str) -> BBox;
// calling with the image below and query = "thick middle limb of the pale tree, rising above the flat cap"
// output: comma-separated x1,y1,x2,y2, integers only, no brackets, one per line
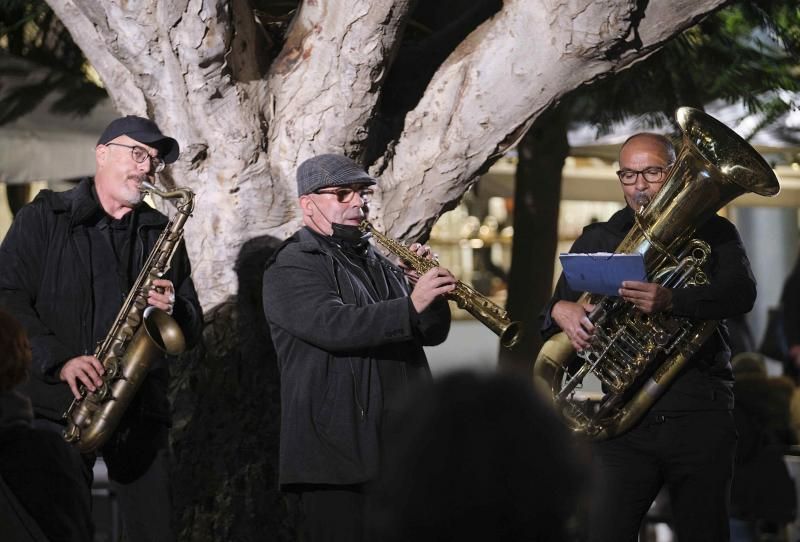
267,0,409,198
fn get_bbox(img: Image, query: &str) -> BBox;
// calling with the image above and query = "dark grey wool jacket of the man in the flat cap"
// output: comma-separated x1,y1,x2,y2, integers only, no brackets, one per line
264,228,450,486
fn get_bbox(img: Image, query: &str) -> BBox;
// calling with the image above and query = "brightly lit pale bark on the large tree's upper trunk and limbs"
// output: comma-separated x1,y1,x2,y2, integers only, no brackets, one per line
49,0,724,307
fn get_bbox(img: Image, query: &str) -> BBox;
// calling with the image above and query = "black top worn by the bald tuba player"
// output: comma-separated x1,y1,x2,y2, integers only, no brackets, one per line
541,207,756,410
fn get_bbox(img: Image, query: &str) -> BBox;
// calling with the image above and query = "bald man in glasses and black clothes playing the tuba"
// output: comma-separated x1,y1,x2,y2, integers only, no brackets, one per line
542,133,756,542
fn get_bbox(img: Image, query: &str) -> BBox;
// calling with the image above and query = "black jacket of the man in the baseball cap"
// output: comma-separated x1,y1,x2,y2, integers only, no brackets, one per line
0,179,202,421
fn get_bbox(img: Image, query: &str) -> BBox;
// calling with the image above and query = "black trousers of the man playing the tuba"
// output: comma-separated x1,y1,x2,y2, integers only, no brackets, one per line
588,410,737,542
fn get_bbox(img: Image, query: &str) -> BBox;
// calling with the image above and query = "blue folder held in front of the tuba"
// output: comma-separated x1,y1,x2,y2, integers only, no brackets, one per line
558,252,647,296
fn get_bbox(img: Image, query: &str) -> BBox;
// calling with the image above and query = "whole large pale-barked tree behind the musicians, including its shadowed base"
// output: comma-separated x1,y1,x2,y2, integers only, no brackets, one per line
43,0,724,541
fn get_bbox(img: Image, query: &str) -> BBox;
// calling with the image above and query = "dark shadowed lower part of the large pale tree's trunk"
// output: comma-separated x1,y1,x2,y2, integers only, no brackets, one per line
171,236,290,542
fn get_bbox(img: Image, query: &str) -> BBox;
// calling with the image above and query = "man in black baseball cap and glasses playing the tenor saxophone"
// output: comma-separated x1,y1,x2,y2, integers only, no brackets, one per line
0,116,202,542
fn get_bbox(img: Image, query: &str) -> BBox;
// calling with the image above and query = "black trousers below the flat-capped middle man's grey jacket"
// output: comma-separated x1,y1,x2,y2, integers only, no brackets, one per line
294,484,365,542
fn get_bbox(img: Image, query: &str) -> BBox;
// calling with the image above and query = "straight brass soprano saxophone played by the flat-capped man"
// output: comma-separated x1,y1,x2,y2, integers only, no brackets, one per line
359,220,522,348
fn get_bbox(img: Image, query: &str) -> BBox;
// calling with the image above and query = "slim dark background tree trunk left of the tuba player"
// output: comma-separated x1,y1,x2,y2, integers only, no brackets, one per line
500,106,569,373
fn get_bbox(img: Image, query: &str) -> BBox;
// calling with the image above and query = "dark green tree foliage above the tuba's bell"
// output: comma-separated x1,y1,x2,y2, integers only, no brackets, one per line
569,1,800,137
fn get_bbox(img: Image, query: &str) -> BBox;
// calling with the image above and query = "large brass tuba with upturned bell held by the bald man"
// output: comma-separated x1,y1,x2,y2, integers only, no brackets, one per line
533,107,780,440
